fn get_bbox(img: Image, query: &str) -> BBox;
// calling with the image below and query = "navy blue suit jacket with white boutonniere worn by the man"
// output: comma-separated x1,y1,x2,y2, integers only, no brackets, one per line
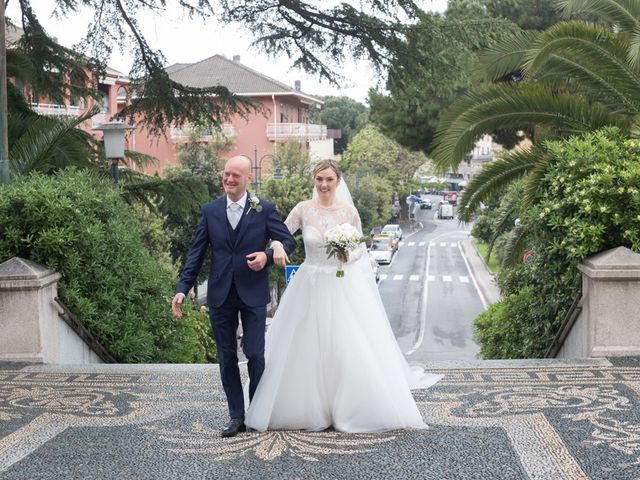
176,196,296,307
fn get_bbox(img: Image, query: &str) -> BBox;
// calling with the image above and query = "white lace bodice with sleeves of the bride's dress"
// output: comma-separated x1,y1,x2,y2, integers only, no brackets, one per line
284,200,366,266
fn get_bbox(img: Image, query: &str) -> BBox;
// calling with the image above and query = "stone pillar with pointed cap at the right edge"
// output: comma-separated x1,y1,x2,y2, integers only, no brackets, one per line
578,247,640,357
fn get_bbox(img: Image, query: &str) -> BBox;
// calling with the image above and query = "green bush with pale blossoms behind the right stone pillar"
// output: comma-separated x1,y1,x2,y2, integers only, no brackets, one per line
476,128,640,358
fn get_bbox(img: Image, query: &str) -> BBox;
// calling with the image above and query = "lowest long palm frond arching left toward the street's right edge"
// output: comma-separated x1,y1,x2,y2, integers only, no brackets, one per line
458,148,543,221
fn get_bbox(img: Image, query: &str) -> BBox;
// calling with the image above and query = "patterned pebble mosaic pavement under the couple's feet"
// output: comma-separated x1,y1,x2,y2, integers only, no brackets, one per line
0,359,640,480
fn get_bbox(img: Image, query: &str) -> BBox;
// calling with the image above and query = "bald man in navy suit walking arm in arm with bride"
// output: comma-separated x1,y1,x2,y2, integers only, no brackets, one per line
171,156,295,437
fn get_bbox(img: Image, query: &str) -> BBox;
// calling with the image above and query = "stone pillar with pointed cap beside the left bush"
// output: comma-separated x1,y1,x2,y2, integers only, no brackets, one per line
0,257,61,363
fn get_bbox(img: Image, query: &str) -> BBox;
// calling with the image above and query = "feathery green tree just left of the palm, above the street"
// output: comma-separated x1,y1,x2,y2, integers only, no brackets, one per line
369,10,517,152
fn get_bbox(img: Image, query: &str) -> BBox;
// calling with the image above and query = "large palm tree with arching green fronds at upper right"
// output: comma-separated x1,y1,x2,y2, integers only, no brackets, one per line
432,0,640,219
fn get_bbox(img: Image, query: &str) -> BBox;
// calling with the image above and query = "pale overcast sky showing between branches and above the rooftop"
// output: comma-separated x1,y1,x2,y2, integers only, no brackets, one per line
6,0,447,102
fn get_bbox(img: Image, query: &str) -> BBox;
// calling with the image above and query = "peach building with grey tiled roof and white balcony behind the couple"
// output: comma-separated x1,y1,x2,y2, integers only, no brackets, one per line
128,55,327,175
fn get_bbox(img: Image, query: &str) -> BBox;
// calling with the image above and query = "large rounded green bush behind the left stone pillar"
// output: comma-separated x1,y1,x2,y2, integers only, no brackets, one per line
0,170,214,363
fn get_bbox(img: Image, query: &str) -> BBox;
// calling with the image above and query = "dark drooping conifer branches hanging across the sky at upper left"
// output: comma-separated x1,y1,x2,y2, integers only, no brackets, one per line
8,0,420,132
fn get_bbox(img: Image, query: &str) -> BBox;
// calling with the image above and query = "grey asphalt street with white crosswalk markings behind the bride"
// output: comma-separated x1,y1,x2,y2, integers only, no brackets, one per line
379,195,485,362
